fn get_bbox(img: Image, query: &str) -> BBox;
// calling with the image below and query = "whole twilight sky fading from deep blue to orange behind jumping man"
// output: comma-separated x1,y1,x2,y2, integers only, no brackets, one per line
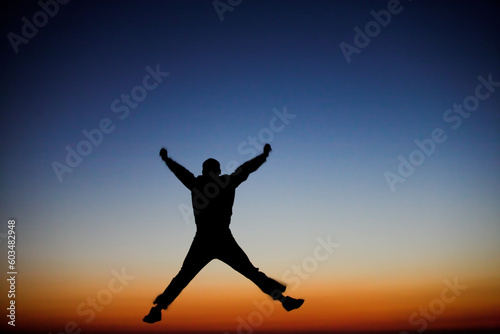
0,0,500,333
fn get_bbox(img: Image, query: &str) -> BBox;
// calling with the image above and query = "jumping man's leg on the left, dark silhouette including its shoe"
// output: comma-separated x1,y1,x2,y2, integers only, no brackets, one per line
143,238,213,323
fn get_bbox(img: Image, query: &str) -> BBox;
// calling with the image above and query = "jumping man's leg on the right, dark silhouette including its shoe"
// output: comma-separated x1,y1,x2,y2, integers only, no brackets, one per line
217,236,304,311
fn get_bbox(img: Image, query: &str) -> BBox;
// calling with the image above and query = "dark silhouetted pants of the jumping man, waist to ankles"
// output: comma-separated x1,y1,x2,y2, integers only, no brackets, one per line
154,230,285,309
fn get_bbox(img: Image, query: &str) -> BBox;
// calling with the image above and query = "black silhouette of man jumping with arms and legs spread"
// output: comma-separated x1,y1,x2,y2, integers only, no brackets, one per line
143,144,304,323
